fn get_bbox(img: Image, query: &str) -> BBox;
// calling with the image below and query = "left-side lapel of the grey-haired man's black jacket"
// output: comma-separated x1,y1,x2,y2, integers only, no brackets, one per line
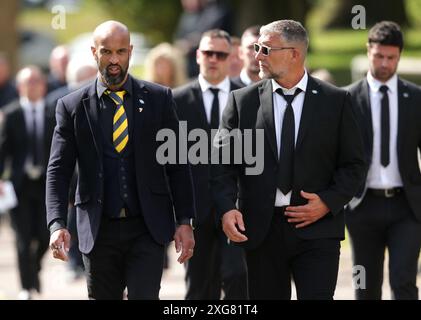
259,80,279,160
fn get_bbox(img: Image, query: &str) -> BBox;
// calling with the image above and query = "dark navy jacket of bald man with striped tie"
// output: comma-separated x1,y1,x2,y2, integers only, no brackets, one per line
46,79,195,253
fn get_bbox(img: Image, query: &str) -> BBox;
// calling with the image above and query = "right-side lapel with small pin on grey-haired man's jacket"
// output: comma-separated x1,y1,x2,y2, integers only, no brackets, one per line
295,75,320,149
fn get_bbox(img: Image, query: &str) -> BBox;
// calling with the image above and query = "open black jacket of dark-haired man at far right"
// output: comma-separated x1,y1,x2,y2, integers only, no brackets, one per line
347,79,421,221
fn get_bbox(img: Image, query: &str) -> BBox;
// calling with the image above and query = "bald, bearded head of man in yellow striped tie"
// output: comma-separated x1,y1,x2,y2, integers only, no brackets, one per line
91,20,133,90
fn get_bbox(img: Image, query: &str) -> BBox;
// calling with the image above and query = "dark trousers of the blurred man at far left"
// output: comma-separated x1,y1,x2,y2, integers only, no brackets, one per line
11,178,50,292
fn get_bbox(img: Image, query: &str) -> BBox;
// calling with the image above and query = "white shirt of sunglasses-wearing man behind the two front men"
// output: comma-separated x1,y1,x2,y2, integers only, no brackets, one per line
199,74,231,124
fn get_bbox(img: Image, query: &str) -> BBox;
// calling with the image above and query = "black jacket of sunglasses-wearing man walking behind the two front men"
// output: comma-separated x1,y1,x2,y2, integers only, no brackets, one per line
174,80,239,225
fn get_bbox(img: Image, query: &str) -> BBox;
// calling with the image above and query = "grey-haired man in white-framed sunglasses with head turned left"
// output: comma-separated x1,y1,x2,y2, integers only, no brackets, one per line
211,20,366,300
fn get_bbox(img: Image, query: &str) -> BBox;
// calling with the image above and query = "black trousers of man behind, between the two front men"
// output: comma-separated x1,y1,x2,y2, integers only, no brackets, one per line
185,214,248,300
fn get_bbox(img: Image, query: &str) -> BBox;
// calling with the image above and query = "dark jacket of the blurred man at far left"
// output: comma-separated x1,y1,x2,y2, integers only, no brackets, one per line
0,100,55,194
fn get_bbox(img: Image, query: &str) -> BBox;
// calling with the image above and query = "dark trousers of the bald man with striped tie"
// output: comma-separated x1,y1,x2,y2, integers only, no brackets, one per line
83,217,164,300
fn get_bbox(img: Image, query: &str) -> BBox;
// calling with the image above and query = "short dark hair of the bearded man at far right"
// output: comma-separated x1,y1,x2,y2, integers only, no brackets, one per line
368,21,403,51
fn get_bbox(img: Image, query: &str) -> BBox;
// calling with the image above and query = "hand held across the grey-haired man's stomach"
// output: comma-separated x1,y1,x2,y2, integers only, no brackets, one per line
285,191,330,228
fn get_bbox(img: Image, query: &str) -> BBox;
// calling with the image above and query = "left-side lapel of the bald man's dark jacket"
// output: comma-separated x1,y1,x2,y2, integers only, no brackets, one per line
82,80,102,159
